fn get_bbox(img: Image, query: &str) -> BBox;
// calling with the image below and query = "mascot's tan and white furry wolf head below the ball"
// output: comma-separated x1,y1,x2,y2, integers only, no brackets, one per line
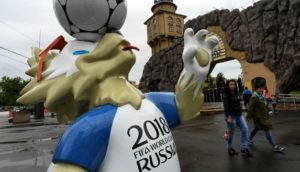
18,33,143,122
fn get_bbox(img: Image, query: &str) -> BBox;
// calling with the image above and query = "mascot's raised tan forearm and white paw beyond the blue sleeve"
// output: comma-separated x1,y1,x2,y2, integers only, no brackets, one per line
176,28,219,121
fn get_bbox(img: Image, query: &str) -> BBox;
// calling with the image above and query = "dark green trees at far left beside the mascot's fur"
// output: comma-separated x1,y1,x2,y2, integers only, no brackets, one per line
0,76,29,106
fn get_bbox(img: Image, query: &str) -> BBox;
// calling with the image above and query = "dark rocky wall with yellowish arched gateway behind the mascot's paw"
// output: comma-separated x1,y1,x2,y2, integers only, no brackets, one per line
139,0,300,94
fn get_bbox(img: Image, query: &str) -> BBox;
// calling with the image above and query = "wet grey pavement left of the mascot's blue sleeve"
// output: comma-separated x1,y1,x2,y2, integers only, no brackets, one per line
0,118,66,172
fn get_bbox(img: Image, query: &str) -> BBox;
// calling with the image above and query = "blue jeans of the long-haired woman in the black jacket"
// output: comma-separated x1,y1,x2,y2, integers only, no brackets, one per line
226,115,248,150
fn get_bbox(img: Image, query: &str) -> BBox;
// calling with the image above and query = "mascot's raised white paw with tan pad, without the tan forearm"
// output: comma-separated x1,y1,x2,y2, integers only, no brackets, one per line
178,28,219,98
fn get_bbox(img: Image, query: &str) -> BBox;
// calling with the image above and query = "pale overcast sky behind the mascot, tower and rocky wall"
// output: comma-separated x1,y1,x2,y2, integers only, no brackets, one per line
0,0,257,81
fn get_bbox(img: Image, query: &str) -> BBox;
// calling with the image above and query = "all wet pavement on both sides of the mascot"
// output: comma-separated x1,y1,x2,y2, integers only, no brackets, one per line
0,111,300,172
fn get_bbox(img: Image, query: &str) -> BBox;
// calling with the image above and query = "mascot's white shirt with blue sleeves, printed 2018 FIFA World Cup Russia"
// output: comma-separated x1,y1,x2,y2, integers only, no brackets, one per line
53,93,180,172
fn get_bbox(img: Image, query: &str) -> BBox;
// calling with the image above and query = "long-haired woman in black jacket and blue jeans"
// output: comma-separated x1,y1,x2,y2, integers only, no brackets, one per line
223,80,252,157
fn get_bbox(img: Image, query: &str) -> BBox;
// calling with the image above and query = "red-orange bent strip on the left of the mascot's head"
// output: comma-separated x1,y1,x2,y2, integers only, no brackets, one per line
36,35,67,81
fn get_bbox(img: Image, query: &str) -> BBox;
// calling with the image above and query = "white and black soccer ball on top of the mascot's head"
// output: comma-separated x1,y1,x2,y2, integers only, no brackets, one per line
53,0,127,40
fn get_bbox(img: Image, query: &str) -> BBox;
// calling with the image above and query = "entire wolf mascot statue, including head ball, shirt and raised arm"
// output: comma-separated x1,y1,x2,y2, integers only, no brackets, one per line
18,0,218,172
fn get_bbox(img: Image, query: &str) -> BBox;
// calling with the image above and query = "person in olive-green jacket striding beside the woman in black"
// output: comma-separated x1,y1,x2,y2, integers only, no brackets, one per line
247,85,284,152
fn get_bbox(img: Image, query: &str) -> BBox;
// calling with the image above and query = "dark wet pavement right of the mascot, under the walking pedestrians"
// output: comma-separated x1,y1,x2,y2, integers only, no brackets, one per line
174,111,300,172
